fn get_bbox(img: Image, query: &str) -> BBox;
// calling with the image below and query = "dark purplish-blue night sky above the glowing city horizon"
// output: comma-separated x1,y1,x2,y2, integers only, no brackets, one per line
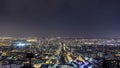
0,0,120,37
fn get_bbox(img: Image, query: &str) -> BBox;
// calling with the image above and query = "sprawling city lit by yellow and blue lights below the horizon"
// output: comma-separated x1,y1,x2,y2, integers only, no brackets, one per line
0,37,120,68
